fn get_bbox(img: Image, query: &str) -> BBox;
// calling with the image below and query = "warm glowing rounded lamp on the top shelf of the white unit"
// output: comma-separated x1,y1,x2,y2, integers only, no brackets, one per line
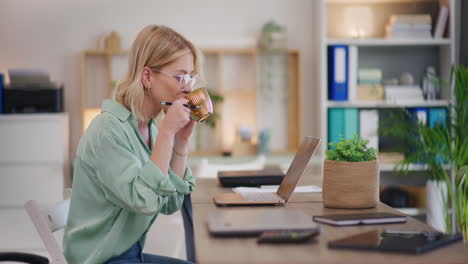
343,6,374,38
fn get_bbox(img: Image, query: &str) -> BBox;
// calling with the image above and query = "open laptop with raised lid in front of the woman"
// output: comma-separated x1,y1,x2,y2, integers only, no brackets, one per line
213,137,320,206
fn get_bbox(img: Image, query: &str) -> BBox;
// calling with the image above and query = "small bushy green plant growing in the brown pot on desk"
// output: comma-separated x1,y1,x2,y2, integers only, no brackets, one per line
327,135,376,162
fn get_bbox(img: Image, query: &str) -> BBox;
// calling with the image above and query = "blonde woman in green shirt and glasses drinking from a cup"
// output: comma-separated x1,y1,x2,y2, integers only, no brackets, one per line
64,25,199,264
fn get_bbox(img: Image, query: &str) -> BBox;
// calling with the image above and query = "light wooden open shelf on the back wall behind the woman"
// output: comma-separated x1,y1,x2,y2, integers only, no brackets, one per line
81,49,301,155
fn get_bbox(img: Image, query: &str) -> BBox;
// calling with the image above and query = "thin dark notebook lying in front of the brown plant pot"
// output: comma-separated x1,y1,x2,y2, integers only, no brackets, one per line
313,213,406,226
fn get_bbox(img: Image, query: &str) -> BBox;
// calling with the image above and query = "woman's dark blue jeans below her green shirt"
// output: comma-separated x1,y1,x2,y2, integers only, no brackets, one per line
106,241,192,264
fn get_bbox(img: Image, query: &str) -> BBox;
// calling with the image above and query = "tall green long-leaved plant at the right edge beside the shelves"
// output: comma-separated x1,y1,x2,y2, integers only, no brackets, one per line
387,66,468,241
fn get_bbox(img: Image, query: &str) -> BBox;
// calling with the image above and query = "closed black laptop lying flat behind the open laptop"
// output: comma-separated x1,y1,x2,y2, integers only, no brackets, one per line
218,166,285,187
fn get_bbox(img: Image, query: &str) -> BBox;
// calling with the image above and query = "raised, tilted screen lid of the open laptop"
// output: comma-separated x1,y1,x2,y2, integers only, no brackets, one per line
277,137,320,201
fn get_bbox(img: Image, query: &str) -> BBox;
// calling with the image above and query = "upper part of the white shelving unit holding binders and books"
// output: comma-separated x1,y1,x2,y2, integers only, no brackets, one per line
320,0,455,157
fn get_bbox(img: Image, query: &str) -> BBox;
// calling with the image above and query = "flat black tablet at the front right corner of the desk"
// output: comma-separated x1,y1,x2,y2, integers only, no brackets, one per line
328,230,463,254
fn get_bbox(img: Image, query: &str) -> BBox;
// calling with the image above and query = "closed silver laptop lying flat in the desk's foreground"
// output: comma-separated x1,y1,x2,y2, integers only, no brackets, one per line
208,209,320,236
